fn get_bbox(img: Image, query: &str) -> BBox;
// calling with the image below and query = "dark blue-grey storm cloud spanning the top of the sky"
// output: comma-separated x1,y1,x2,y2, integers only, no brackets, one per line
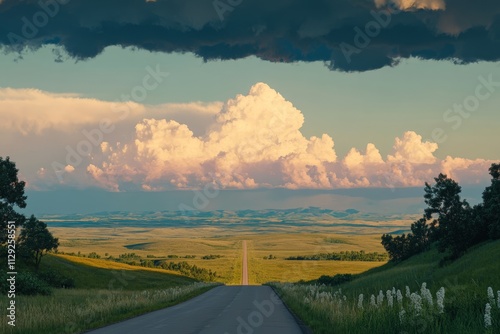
0,0,500,71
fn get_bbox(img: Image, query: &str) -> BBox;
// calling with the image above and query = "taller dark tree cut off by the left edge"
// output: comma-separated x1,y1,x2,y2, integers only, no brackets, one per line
0,157,26,245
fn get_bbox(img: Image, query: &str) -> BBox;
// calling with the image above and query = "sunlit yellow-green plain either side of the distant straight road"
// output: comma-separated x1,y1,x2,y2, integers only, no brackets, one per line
51,228,390,284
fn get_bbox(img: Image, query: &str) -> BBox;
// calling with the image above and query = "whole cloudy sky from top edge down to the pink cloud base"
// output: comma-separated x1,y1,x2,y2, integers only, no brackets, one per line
0,0,500,211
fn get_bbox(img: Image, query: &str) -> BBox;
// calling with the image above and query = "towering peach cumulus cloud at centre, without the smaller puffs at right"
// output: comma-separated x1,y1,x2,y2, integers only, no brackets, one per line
84,83,336,189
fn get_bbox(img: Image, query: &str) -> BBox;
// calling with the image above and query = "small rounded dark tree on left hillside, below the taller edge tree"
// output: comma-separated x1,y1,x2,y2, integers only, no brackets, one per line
18,215,59,271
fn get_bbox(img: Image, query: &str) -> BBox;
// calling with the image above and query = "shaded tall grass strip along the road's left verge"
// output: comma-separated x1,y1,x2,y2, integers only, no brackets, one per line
0,283,215,334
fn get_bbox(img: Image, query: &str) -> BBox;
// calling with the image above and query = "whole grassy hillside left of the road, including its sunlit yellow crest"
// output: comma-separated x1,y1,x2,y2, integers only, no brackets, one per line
0,255,215,334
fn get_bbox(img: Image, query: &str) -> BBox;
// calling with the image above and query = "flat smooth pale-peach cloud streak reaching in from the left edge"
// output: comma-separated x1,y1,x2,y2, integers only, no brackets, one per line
0,88,222,136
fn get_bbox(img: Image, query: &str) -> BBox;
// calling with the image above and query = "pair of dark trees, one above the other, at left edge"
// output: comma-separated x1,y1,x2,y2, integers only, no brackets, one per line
0,157,59,271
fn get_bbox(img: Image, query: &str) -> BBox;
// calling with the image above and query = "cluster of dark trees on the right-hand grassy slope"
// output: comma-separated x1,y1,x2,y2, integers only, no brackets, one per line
382,164,500,261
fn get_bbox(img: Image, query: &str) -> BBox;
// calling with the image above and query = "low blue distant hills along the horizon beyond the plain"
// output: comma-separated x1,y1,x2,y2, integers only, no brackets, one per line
40,206,416,228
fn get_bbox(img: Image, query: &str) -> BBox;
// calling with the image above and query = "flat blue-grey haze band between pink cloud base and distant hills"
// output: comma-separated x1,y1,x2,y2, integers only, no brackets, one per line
23,187,484,218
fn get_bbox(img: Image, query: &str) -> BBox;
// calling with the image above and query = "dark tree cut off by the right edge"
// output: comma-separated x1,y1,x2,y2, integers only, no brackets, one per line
482,163,500,239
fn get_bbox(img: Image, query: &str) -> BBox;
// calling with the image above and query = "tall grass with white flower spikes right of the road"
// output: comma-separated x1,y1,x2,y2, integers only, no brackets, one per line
273,283,500,334
